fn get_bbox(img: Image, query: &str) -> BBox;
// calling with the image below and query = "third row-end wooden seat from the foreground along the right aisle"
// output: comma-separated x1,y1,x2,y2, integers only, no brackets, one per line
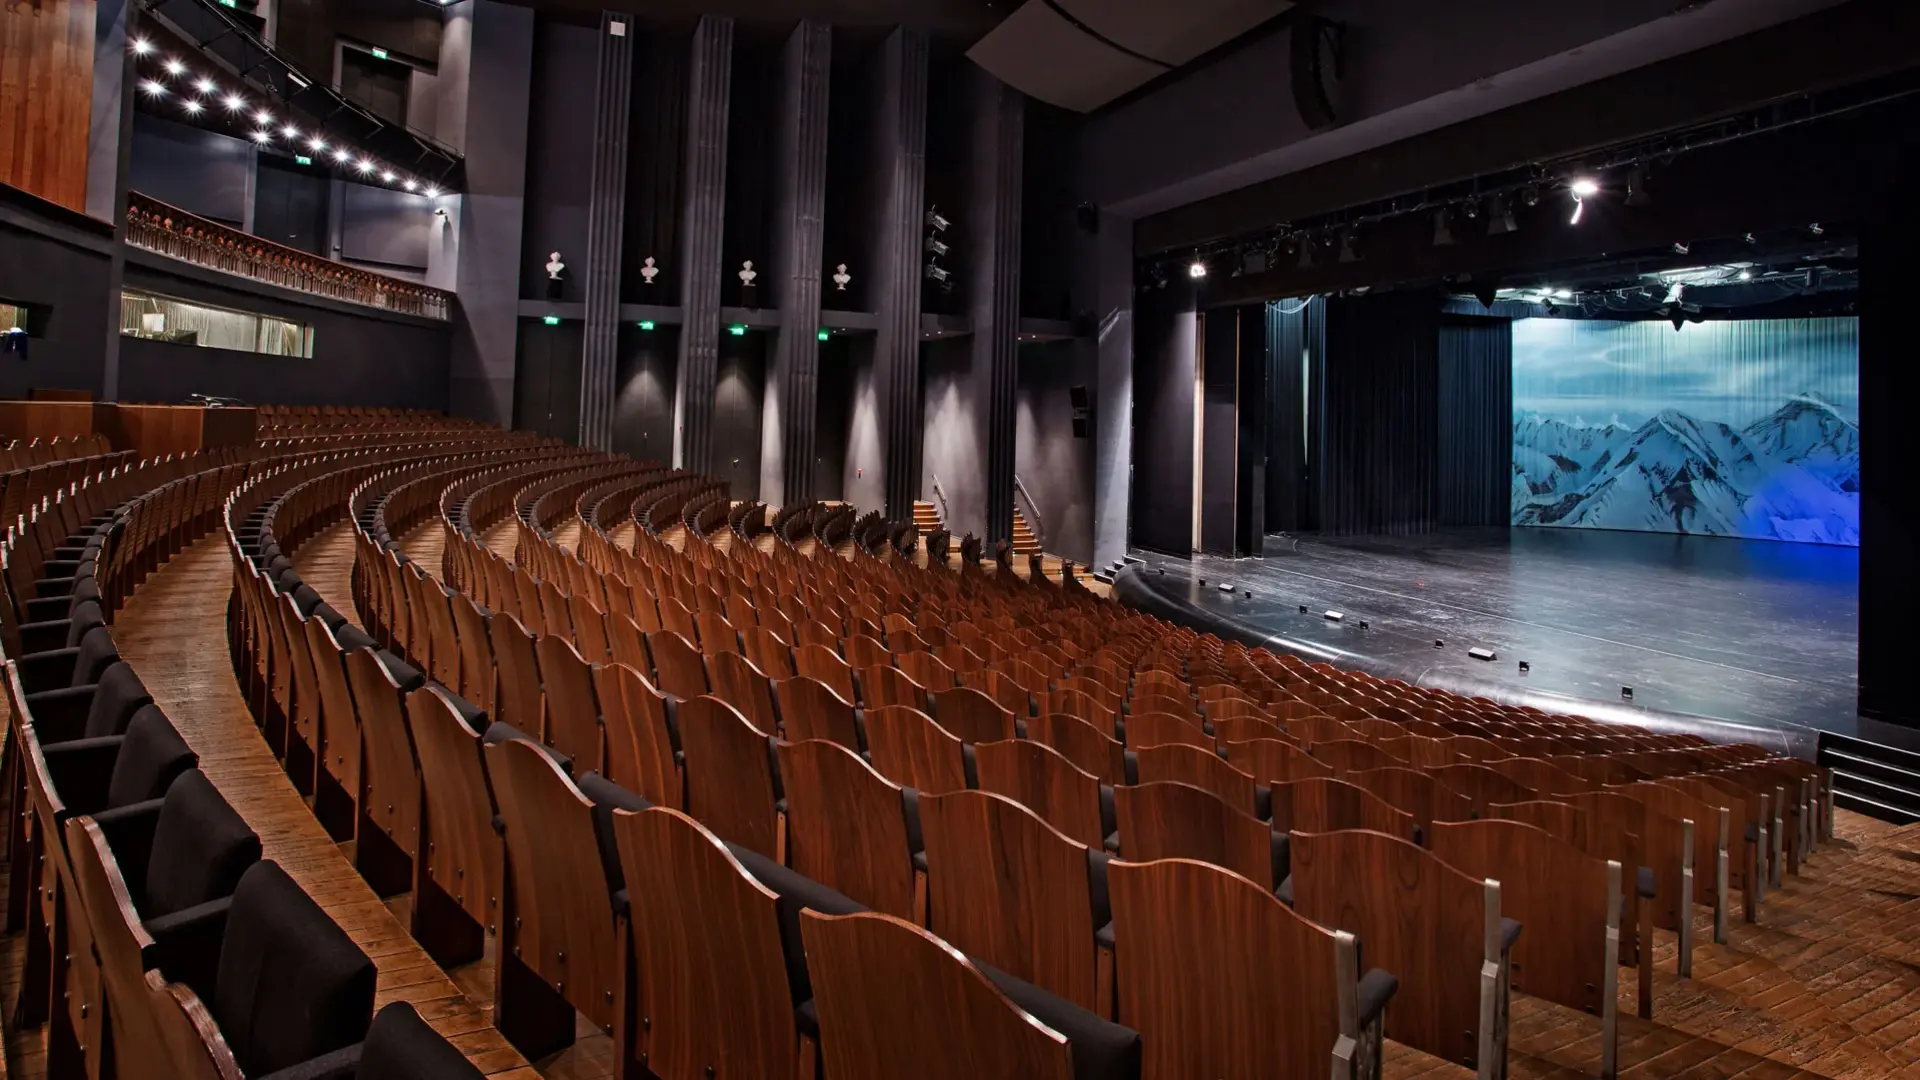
1430,821,1620,1076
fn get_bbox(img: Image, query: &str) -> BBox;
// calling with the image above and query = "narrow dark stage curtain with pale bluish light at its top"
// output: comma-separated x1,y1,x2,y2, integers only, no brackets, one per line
1263,296,1327,532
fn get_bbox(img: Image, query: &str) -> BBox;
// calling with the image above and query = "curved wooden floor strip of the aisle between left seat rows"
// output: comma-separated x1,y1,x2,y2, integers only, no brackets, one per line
59,530,536,1080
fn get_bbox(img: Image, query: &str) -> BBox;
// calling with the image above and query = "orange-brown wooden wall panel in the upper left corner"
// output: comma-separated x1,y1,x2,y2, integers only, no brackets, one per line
0,0,94,211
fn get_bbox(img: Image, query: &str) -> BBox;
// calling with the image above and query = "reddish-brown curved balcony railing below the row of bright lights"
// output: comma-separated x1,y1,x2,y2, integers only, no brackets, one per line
127,192,453,319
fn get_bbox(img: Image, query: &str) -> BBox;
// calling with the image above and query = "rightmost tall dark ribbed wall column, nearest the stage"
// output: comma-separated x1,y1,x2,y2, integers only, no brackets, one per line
968,67,1027,544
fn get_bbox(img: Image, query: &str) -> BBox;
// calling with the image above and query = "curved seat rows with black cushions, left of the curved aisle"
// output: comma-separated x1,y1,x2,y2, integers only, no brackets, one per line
0,422,526,1080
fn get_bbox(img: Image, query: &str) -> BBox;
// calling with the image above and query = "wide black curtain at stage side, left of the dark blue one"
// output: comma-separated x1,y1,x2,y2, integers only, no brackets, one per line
1309,290,1440,534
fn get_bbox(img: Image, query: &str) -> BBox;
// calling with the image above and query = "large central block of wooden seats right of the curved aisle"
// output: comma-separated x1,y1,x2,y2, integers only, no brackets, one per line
11,409,1832,1080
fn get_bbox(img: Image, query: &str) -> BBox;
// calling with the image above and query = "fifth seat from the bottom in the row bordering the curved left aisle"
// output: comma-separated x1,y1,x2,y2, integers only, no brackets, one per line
346,650,424,896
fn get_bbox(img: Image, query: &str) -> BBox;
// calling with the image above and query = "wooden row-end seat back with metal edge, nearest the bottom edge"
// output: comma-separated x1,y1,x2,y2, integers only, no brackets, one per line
1108,861,1396,1080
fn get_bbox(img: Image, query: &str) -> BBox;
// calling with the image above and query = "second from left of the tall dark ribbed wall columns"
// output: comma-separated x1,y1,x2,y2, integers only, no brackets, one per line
674,15,733,473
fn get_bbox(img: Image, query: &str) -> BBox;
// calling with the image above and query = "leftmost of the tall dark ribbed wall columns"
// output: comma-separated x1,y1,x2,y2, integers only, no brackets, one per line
578,12,634,450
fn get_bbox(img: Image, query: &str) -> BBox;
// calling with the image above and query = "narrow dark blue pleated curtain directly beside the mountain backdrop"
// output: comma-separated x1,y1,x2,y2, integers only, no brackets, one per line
1440,315,1513,525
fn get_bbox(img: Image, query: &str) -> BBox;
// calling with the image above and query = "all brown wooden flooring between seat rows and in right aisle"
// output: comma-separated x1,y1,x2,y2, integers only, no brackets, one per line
11,507,1920,1080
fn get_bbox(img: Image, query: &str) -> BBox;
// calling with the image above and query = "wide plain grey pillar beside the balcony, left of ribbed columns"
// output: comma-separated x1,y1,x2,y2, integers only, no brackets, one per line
444,0,534,427
